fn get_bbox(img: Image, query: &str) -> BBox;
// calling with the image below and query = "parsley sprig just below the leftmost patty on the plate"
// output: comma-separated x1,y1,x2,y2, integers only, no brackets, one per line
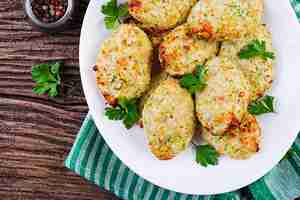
105,98,140,129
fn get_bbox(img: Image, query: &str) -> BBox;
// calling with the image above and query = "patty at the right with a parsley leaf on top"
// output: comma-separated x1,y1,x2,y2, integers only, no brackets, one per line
220,25,274,100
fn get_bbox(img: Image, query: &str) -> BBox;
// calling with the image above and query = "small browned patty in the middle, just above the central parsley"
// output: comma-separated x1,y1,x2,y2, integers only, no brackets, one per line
159,24,218,76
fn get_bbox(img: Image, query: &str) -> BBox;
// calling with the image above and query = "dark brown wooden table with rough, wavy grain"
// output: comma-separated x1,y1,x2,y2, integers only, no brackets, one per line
0,0,117,200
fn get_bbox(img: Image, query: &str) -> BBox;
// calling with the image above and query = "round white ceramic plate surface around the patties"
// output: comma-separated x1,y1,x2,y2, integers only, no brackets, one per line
80,0,300,195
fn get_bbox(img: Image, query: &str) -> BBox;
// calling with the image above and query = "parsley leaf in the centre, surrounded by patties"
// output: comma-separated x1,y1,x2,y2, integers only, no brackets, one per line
180,65,207,94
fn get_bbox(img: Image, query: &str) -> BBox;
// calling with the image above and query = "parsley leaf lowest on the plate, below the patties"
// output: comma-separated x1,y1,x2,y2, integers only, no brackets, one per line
196,144,220,167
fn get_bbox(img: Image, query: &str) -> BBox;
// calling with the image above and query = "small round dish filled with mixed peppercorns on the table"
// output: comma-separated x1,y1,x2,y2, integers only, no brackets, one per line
24,0,76,32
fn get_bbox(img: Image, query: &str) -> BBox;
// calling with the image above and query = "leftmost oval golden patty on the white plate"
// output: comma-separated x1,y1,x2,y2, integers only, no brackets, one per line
96,24,152,105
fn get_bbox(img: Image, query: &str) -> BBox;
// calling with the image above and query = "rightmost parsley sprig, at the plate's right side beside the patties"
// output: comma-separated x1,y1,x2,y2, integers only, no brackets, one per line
248,95,275,115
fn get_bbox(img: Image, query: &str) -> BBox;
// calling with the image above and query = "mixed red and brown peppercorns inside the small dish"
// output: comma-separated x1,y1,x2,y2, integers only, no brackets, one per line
31,0,68,23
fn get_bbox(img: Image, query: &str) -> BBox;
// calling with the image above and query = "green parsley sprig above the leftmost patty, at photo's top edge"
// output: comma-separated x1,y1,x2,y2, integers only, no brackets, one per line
101,0,128,29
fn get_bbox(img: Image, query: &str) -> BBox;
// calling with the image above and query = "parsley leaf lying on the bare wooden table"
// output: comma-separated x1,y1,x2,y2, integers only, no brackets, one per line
31,62,61,97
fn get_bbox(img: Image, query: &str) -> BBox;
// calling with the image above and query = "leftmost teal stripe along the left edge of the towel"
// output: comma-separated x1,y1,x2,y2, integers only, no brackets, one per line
69,120,93,170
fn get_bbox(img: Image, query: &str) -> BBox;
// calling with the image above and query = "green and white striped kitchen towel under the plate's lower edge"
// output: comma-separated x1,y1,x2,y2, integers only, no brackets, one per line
65,115,300,200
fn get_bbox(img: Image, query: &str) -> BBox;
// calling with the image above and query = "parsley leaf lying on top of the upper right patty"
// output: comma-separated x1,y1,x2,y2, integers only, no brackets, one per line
238,39,275,60
